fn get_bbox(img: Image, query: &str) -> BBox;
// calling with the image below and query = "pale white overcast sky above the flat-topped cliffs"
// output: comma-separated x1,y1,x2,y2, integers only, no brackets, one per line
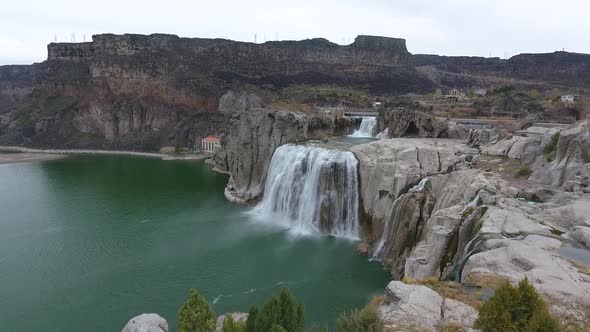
0,0,590,64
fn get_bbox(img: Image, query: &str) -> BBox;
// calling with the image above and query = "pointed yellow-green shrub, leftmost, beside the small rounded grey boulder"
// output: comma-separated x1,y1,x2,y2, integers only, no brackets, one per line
178,288,215,332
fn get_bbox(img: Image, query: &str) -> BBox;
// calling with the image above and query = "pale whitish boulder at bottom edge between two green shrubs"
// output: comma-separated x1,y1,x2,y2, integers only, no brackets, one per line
379,281,477,331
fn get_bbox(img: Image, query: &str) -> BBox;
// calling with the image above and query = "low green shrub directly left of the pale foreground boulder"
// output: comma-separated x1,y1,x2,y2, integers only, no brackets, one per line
336,305,383,332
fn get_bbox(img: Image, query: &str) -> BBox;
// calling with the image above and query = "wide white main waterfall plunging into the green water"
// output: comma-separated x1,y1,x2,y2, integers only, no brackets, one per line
252,144,359,239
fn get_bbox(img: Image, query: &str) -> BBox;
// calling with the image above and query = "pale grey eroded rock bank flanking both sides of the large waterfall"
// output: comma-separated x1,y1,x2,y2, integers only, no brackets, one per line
215,109,590,331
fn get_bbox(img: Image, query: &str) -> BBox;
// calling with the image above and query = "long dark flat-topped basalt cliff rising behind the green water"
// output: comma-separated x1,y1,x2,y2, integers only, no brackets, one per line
0,34,433,150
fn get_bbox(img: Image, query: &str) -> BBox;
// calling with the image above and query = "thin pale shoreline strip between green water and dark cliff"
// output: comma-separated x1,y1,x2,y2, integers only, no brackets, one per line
0,146,209,160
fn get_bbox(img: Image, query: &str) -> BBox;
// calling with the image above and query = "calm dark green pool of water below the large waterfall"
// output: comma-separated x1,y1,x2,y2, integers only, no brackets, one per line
0,156,388,332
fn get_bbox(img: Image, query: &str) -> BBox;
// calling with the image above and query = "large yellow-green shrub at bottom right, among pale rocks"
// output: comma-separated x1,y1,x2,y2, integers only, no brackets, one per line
474,278,560,332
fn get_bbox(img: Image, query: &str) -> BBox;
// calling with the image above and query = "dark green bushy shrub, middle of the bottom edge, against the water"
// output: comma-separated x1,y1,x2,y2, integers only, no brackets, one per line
246,289,305,332
